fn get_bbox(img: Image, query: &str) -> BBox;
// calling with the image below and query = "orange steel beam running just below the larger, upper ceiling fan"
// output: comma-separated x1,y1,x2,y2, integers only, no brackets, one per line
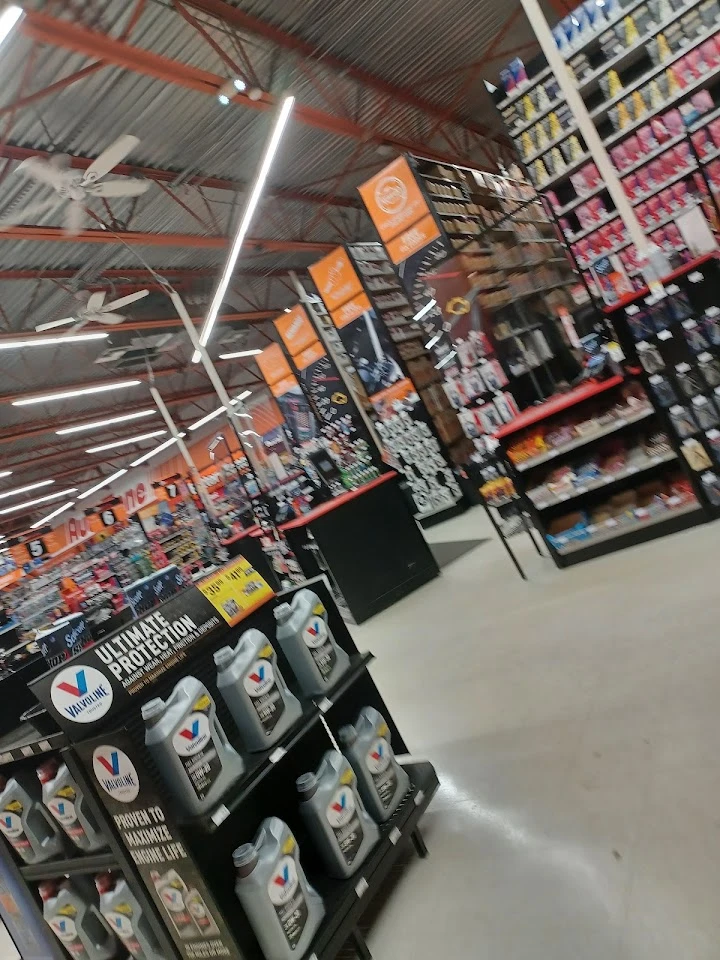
0,227,337,253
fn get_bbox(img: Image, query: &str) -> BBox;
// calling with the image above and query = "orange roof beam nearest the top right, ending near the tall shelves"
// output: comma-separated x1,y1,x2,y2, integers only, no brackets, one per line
185,0,506,140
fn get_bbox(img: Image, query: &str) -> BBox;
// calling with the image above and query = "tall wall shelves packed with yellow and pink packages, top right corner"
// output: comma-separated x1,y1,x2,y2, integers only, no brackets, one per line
495,0,720,288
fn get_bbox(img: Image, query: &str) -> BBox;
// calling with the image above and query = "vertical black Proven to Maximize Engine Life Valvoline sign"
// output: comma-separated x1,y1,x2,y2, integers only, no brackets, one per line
78,732,242,960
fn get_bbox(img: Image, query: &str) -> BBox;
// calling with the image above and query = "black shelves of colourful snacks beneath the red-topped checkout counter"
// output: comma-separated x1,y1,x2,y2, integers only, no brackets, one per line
496,371,708,567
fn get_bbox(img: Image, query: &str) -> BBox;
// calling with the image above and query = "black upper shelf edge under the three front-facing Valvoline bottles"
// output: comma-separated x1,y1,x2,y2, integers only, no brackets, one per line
186,653,375,833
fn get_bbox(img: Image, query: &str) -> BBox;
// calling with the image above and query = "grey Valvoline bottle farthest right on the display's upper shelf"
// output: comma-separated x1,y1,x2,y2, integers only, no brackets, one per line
275,590,350,696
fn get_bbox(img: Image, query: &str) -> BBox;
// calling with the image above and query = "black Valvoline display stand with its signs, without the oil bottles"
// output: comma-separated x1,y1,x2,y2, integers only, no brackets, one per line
26,565,439,960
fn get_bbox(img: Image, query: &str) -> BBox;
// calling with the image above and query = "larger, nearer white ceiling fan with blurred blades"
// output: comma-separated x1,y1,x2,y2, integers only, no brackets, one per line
0,134,150,235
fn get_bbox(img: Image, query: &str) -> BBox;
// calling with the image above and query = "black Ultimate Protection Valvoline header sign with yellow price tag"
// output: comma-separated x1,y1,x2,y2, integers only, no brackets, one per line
31,557,274,739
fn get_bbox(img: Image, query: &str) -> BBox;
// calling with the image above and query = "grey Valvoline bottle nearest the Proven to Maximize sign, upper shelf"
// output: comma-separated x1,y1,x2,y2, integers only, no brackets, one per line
142,677,244,814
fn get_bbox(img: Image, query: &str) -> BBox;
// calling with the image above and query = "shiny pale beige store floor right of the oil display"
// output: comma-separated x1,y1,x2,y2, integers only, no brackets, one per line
353,509,720,960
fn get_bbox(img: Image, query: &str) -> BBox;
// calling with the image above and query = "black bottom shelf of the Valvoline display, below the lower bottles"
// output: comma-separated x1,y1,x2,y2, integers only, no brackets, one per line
305,762,440,960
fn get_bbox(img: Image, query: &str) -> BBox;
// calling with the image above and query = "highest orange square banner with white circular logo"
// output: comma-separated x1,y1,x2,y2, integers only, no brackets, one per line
358,157,430,244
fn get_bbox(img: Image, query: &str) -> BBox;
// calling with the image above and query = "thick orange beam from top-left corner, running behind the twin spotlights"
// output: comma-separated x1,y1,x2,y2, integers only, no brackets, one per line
20,10,492,163
